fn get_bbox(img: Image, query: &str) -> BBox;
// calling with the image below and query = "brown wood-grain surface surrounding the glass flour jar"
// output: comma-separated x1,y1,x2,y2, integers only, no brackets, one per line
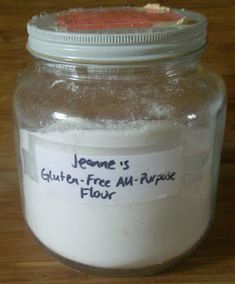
0,0,235,284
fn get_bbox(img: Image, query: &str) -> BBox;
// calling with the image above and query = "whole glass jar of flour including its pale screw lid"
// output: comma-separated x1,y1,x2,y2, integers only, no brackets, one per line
14,5,225,275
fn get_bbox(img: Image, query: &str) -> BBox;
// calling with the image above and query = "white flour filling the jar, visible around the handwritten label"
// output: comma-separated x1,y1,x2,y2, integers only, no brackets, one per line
20,120,211,268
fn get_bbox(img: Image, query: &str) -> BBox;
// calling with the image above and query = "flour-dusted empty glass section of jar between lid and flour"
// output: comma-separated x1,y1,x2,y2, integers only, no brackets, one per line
15,63,225,129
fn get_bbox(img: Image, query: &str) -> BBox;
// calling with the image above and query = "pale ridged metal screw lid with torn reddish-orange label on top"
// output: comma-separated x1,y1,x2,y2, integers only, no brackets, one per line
27,4,207,63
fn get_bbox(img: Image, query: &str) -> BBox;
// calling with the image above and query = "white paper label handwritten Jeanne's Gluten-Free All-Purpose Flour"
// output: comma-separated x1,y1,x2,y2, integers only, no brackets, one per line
24,144,184,205
